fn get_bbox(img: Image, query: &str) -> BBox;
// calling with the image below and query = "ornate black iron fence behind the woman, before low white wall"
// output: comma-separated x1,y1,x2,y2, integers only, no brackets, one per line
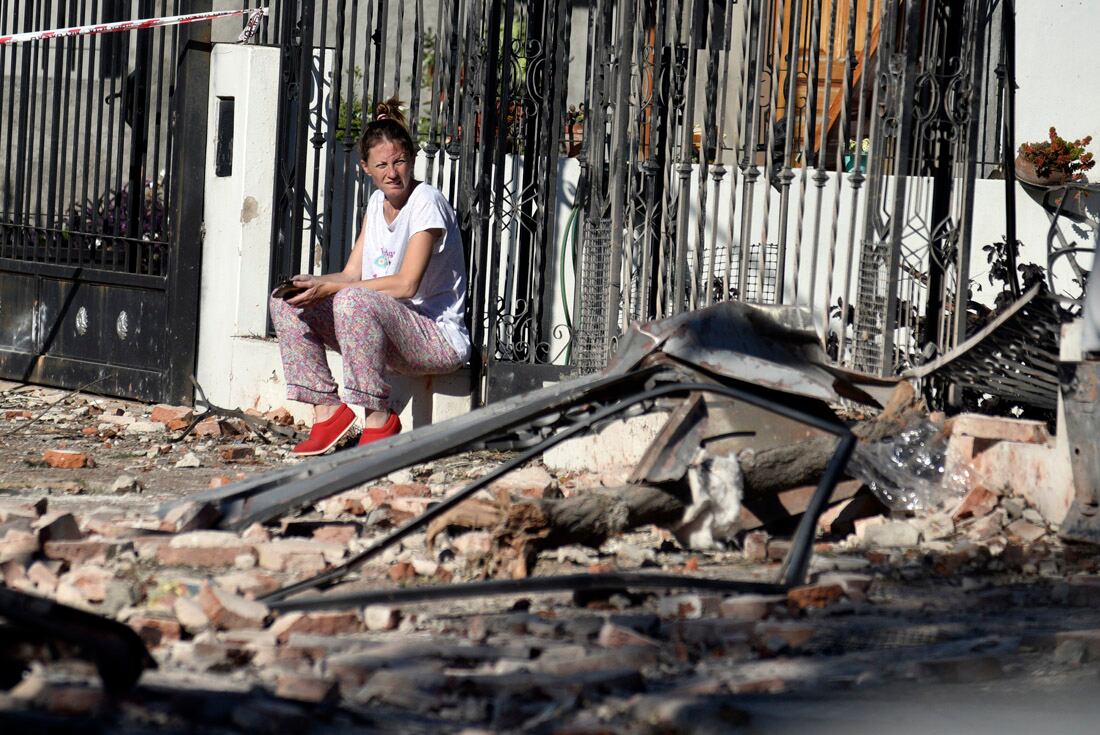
268,0,1003,398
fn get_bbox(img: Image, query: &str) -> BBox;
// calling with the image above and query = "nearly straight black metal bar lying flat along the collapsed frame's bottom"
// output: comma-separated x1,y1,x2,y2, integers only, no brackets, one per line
268,572,788,611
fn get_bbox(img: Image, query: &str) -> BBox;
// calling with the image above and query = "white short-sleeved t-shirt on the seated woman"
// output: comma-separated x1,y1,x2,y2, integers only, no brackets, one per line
363,182,470,360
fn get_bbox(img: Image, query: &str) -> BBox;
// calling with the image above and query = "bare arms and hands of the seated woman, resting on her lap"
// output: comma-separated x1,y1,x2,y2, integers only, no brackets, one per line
287,228,443,306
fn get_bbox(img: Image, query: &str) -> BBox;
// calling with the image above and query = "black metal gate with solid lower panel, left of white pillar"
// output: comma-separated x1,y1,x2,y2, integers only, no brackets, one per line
0,0,210,403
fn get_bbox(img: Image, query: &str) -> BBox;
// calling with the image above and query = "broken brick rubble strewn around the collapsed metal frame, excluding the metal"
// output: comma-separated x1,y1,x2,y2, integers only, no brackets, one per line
0,407,1100,732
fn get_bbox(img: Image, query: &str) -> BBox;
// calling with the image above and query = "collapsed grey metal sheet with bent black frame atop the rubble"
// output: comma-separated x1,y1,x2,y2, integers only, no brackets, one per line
162,303,876,608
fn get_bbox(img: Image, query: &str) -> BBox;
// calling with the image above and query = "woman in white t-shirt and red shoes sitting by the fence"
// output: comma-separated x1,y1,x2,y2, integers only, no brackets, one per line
271,99,470,456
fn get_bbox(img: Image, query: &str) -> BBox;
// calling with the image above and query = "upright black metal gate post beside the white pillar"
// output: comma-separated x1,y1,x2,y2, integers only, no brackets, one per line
163,0,211,405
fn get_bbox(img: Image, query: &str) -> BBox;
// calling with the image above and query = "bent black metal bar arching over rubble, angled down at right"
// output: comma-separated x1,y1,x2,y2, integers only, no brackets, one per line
261,382,855,601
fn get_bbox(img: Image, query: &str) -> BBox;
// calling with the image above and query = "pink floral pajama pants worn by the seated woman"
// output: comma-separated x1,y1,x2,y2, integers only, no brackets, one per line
270,288,462,410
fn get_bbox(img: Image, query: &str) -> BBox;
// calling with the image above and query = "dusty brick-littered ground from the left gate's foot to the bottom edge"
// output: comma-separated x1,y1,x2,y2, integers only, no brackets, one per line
0,385,1100,733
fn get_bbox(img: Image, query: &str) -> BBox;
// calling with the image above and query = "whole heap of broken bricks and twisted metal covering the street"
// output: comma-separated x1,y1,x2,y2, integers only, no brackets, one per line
0,304,1100,733
